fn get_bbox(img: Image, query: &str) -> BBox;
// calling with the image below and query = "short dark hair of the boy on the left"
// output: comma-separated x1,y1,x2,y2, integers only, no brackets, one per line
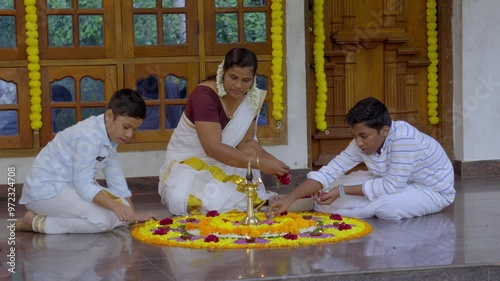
106,89,147,120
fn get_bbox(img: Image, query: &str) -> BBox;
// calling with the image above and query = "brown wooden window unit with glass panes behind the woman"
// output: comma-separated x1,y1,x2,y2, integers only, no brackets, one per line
0,0,286,154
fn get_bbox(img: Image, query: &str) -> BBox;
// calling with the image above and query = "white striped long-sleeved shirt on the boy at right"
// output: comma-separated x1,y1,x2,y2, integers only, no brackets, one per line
307,121,455,207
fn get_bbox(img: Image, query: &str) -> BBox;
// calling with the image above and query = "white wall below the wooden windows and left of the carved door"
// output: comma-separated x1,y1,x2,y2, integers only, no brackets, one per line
0,1,308,184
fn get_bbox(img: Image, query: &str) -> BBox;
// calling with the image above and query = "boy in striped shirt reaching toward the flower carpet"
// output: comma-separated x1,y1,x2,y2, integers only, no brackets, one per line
266,97,455,220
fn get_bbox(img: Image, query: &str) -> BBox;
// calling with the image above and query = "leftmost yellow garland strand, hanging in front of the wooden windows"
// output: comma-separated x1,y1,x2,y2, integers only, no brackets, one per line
24,0,42,131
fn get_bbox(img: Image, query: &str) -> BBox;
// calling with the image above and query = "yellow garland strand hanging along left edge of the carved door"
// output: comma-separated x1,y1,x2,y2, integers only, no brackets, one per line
313,0,328,131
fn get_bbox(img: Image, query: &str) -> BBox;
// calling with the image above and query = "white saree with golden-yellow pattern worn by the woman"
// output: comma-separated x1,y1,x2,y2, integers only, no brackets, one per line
158,91,270,215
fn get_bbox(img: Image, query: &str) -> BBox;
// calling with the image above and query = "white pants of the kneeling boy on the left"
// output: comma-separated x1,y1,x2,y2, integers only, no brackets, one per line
26,186,129,234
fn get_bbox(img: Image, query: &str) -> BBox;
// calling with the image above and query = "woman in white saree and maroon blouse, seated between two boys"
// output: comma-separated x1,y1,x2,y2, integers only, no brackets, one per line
158,48,290,215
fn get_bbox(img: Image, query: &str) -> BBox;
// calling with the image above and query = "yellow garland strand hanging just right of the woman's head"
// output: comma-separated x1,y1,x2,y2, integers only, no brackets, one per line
271,0,283,121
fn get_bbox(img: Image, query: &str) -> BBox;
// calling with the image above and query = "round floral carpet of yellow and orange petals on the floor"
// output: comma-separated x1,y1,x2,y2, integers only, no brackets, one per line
131,212,372,249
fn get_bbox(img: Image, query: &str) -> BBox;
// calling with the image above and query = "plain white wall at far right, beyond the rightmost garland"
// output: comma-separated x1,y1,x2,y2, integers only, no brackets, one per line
453,0,500,162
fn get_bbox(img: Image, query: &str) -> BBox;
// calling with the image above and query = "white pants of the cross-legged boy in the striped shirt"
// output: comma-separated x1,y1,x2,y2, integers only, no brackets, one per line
314,171,448,220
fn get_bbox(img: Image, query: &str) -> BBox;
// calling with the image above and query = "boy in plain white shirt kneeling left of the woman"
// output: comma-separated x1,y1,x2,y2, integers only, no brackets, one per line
16,89,152,234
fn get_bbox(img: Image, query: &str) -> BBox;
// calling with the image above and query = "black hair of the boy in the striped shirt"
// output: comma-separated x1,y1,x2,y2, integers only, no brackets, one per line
345,97,392,131
